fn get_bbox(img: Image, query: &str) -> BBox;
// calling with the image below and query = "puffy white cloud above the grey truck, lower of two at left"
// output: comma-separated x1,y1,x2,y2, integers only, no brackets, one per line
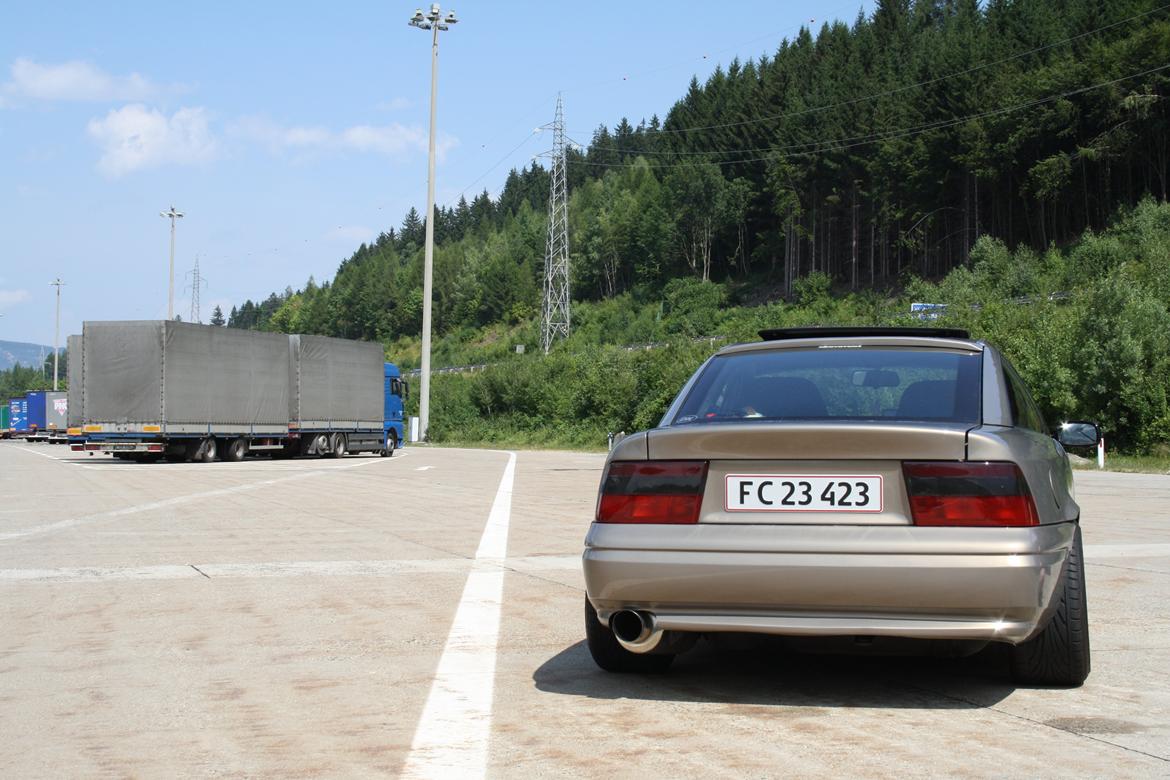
88,104,219,177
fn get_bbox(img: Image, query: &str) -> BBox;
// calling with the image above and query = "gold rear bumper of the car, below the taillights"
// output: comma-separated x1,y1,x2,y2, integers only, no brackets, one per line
584,523,1075,643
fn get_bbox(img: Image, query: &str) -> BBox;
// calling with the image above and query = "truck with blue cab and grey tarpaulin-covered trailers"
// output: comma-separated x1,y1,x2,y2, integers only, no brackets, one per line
69,320,407,462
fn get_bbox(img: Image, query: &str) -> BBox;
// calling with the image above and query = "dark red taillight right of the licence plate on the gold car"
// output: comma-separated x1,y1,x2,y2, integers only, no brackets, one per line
902,462,1040,526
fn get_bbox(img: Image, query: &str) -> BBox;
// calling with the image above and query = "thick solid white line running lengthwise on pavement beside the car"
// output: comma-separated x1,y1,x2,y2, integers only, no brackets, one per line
402,453,516,780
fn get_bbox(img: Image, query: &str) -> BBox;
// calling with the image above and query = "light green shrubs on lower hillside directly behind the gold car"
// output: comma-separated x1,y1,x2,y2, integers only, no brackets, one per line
430,199,1170,457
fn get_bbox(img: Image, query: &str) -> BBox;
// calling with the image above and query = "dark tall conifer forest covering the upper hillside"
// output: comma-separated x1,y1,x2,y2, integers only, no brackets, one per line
227,0,1170,341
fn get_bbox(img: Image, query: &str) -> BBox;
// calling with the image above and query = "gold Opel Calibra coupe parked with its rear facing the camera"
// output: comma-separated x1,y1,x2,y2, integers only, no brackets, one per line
584,327,1100,685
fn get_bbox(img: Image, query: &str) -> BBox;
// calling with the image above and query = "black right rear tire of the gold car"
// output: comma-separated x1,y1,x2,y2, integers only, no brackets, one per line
1011,526,1092,688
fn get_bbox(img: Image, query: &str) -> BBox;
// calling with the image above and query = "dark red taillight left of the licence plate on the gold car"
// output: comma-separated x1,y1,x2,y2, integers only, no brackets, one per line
597,461,707,524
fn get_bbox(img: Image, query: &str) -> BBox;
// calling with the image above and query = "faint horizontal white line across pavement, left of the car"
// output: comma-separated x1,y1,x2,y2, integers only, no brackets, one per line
0,555,581,582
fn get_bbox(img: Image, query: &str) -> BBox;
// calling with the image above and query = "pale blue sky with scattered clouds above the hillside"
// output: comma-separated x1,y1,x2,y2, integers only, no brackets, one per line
0,0,873,344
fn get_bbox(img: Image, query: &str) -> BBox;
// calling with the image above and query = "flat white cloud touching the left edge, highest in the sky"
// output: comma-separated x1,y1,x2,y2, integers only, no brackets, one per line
0,58,161,104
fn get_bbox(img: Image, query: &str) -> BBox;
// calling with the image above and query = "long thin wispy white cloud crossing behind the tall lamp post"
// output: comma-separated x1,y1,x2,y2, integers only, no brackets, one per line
232,117,459,160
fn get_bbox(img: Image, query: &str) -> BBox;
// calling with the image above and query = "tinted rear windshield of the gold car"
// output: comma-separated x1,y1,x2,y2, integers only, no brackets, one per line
672,347,982,426
